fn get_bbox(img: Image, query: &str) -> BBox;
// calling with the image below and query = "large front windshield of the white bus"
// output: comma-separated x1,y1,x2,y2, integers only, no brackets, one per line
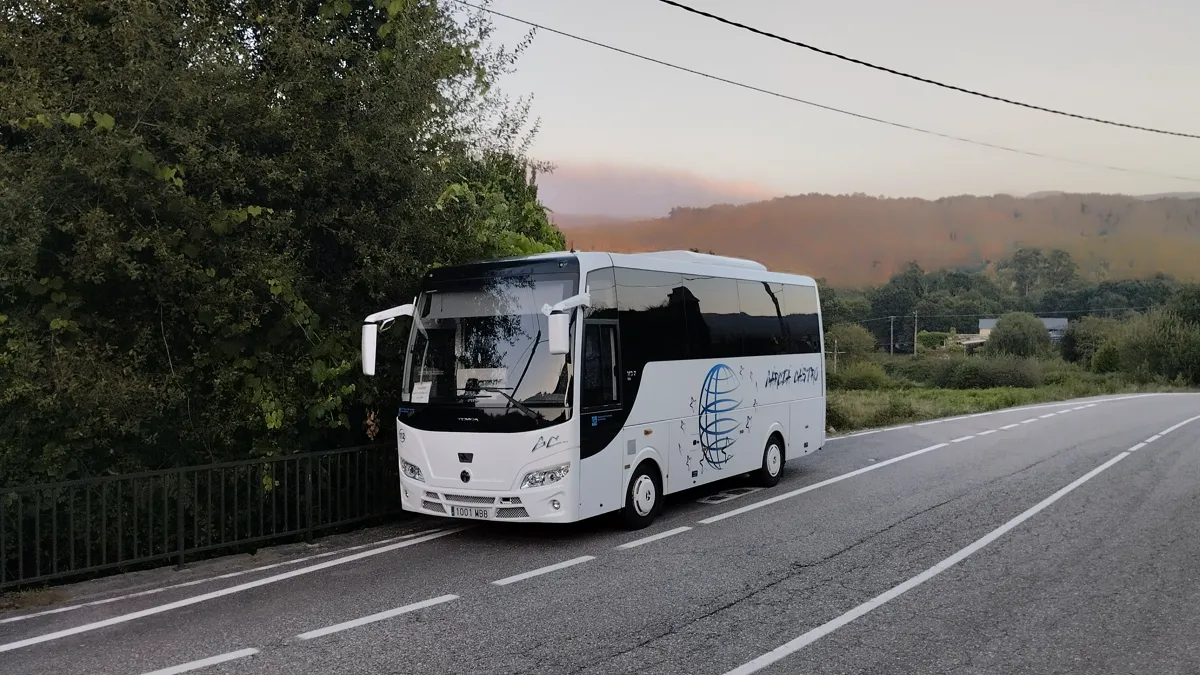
403,269,577,431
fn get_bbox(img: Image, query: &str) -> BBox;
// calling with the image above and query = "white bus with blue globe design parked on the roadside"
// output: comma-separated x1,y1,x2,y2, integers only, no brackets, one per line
362,251,826,528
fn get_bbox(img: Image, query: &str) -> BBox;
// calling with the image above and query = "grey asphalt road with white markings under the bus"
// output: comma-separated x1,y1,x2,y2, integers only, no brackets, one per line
0,395,1200,675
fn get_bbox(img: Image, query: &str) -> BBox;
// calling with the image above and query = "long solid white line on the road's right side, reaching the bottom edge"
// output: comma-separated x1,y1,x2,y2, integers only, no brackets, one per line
725,453,1129,675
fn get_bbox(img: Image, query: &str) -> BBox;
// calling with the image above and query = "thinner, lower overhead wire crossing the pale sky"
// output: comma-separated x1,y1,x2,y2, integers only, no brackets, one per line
454,0,1200,183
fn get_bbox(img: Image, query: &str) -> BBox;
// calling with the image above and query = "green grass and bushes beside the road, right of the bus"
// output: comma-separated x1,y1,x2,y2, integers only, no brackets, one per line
827,286,1200,434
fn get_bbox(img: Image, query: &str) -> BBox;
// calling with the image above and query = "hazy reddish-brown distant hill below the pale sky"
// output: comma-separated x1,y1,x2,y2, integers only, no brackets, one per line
564,193,1200,286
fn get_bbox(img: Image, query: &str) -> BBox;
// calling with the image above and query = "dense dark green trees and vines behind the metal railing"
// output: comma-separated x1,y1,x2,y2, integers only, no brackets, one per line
0,0,563,484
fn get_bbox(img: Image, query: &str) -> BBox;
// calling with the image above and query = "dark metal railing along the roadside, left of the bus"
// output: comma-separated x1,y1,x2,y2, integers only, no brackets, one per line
0,446,400,590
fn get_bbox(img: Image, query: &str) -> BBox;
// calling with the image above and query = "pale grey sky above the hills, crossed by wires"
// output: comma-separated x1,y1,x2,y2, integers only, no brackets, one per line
491,0,1200,198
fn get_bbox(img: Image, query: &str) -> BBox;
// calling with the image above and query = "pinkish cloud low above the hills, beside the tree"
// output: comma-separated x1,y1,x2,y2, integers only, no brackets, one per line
538,162,778,219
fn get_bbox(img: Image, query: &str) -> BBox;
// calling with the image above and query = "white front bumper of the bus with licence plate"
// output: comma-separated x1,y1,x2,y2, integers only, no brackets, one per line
400,476,578,522
